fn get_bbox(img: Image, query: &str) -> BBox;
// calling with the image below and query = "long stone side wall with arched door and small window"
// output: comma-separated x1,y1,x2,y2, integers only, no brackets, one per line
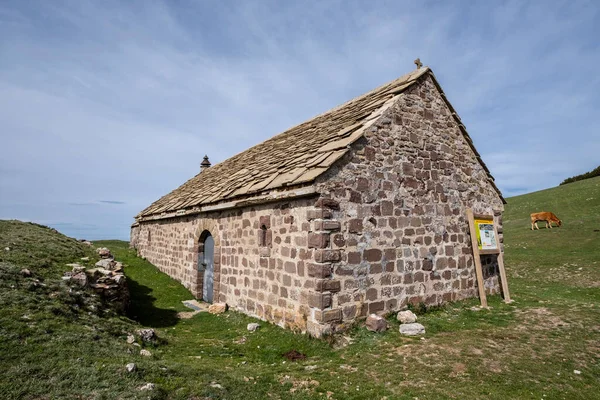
136,199,338,334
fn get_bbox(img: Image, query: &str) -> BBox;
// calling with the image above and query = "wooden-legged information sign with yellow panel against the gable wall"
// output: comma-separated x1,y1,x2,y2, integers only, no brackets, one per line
467,208,512,308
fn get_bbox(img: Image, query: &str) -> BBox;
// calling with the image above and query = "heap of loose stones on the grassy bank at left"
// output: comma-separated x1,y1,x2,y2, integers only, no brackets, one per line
63,248,129,312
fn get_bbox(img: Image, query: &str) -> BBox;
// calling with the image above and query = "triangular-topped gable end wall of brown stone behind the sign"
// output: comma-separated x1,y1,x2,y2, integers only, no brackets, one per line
311,77,504,328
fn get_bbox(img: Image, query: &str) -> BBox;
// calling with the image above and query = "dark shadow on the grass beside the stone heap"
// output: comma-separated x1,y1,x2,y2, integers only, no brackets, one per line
127,278,178,328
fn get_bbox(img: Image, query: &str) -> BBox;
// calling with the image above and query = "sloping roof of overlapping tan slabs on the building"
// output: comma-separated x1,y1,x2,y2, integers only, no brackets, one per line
136,67,504,219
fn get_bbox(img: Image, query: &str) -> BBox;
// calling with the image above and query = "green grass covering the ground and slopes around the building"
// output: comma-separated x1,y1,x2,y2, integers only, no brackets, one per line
0,178,600,399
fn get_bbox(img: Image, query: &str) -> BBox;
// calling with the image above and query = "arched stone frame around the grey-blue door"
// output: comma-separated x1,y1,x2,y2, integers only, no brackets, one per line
191,220,225,303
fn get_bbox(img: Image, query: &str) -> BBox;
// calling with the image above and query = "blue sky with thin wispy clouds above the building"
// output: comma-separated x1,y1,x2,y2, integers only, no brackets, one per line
0,0,600,240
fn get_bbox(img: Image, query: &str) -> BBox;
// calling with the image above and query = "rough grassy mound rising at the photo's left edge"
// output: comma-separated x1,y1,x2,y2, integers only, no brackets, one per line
0,221,165,399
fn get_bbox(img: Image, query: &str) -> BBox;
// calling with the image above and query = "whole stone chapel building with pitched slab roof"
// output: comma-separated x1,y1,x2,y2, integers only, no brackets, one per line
131,67,505,336
